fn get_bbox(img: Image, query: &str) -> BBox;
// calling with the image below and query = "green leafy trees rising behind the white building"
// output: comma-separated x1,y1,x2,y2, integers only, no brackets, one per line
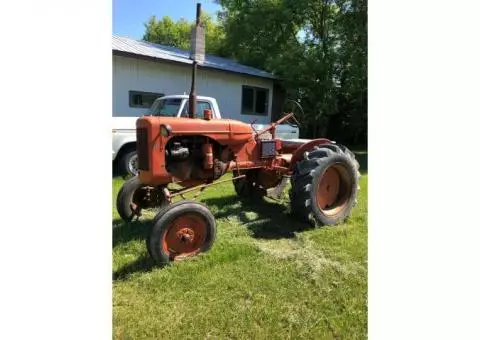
144,0,368,145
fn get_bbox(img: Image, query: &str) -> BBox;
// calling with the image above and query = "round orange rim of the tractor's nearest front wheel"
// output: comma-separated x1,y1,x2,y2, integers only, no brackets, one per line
162,213,207,260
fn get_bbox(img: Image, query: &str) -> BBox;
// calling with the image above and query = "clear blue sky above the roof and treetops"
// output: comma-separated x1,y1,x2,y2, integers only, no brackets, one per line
112,0,221,39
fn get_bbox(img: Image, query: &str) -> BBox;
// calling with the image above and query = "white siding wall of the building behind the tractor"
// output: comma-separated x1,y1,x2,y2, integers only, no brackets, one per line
113,55,273,123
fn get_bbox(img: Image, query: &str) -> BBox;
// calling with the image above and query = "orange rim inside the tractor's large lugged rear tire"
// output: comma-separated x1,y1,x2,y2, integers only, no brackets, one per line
317,163,352,216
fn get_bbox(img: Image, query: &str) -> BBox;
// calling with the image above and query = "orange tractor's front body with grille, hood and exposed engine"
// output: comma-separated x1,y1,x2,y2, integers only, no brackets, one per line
137,114,258,186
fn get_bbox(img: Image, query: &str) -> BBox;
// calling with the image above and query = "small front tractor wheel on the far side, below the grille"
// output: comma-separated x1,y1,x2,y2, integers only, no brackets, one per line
117,177,169,222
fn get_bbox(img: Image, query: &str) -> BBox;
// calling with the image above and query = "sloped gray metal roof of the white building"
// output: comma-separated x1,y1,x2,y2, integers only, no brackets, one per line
112,35,275,79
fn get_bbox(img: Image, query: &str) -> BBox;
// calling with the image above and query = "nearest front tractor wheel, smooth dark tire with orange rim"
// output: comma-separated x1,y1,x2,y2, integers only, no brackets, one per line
146,200,216,265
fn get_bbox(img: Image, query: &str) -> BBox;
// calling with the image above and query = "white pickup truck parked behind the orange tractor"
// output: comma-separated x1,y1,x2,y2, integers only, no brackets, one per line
112,95,299,175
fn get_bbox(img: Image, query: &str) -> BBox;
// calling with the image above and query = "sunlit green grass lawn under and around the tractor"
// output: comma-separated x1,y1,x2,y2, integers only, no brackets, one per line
112,154,368,339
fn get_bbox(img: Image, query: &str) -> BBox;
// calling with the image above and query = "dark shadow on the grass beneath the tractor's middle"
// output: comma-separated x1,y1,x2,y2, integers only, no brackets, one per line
203,195,314,240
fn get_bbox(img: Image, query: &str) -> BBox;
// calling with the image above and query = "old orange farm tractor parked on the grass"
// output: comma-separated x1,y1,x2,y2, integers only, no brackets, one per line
117,110,360,264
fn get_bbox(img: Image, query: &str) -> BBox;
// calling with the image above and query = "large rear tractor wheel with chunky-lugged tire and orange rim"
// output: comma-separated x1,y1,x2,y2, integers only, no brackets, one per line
290,144,360,225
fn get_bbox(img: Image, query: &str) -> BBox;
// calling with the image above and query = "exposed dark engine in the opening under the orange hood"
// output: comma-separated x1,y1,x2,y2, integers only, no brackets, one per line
165,136,232,181
